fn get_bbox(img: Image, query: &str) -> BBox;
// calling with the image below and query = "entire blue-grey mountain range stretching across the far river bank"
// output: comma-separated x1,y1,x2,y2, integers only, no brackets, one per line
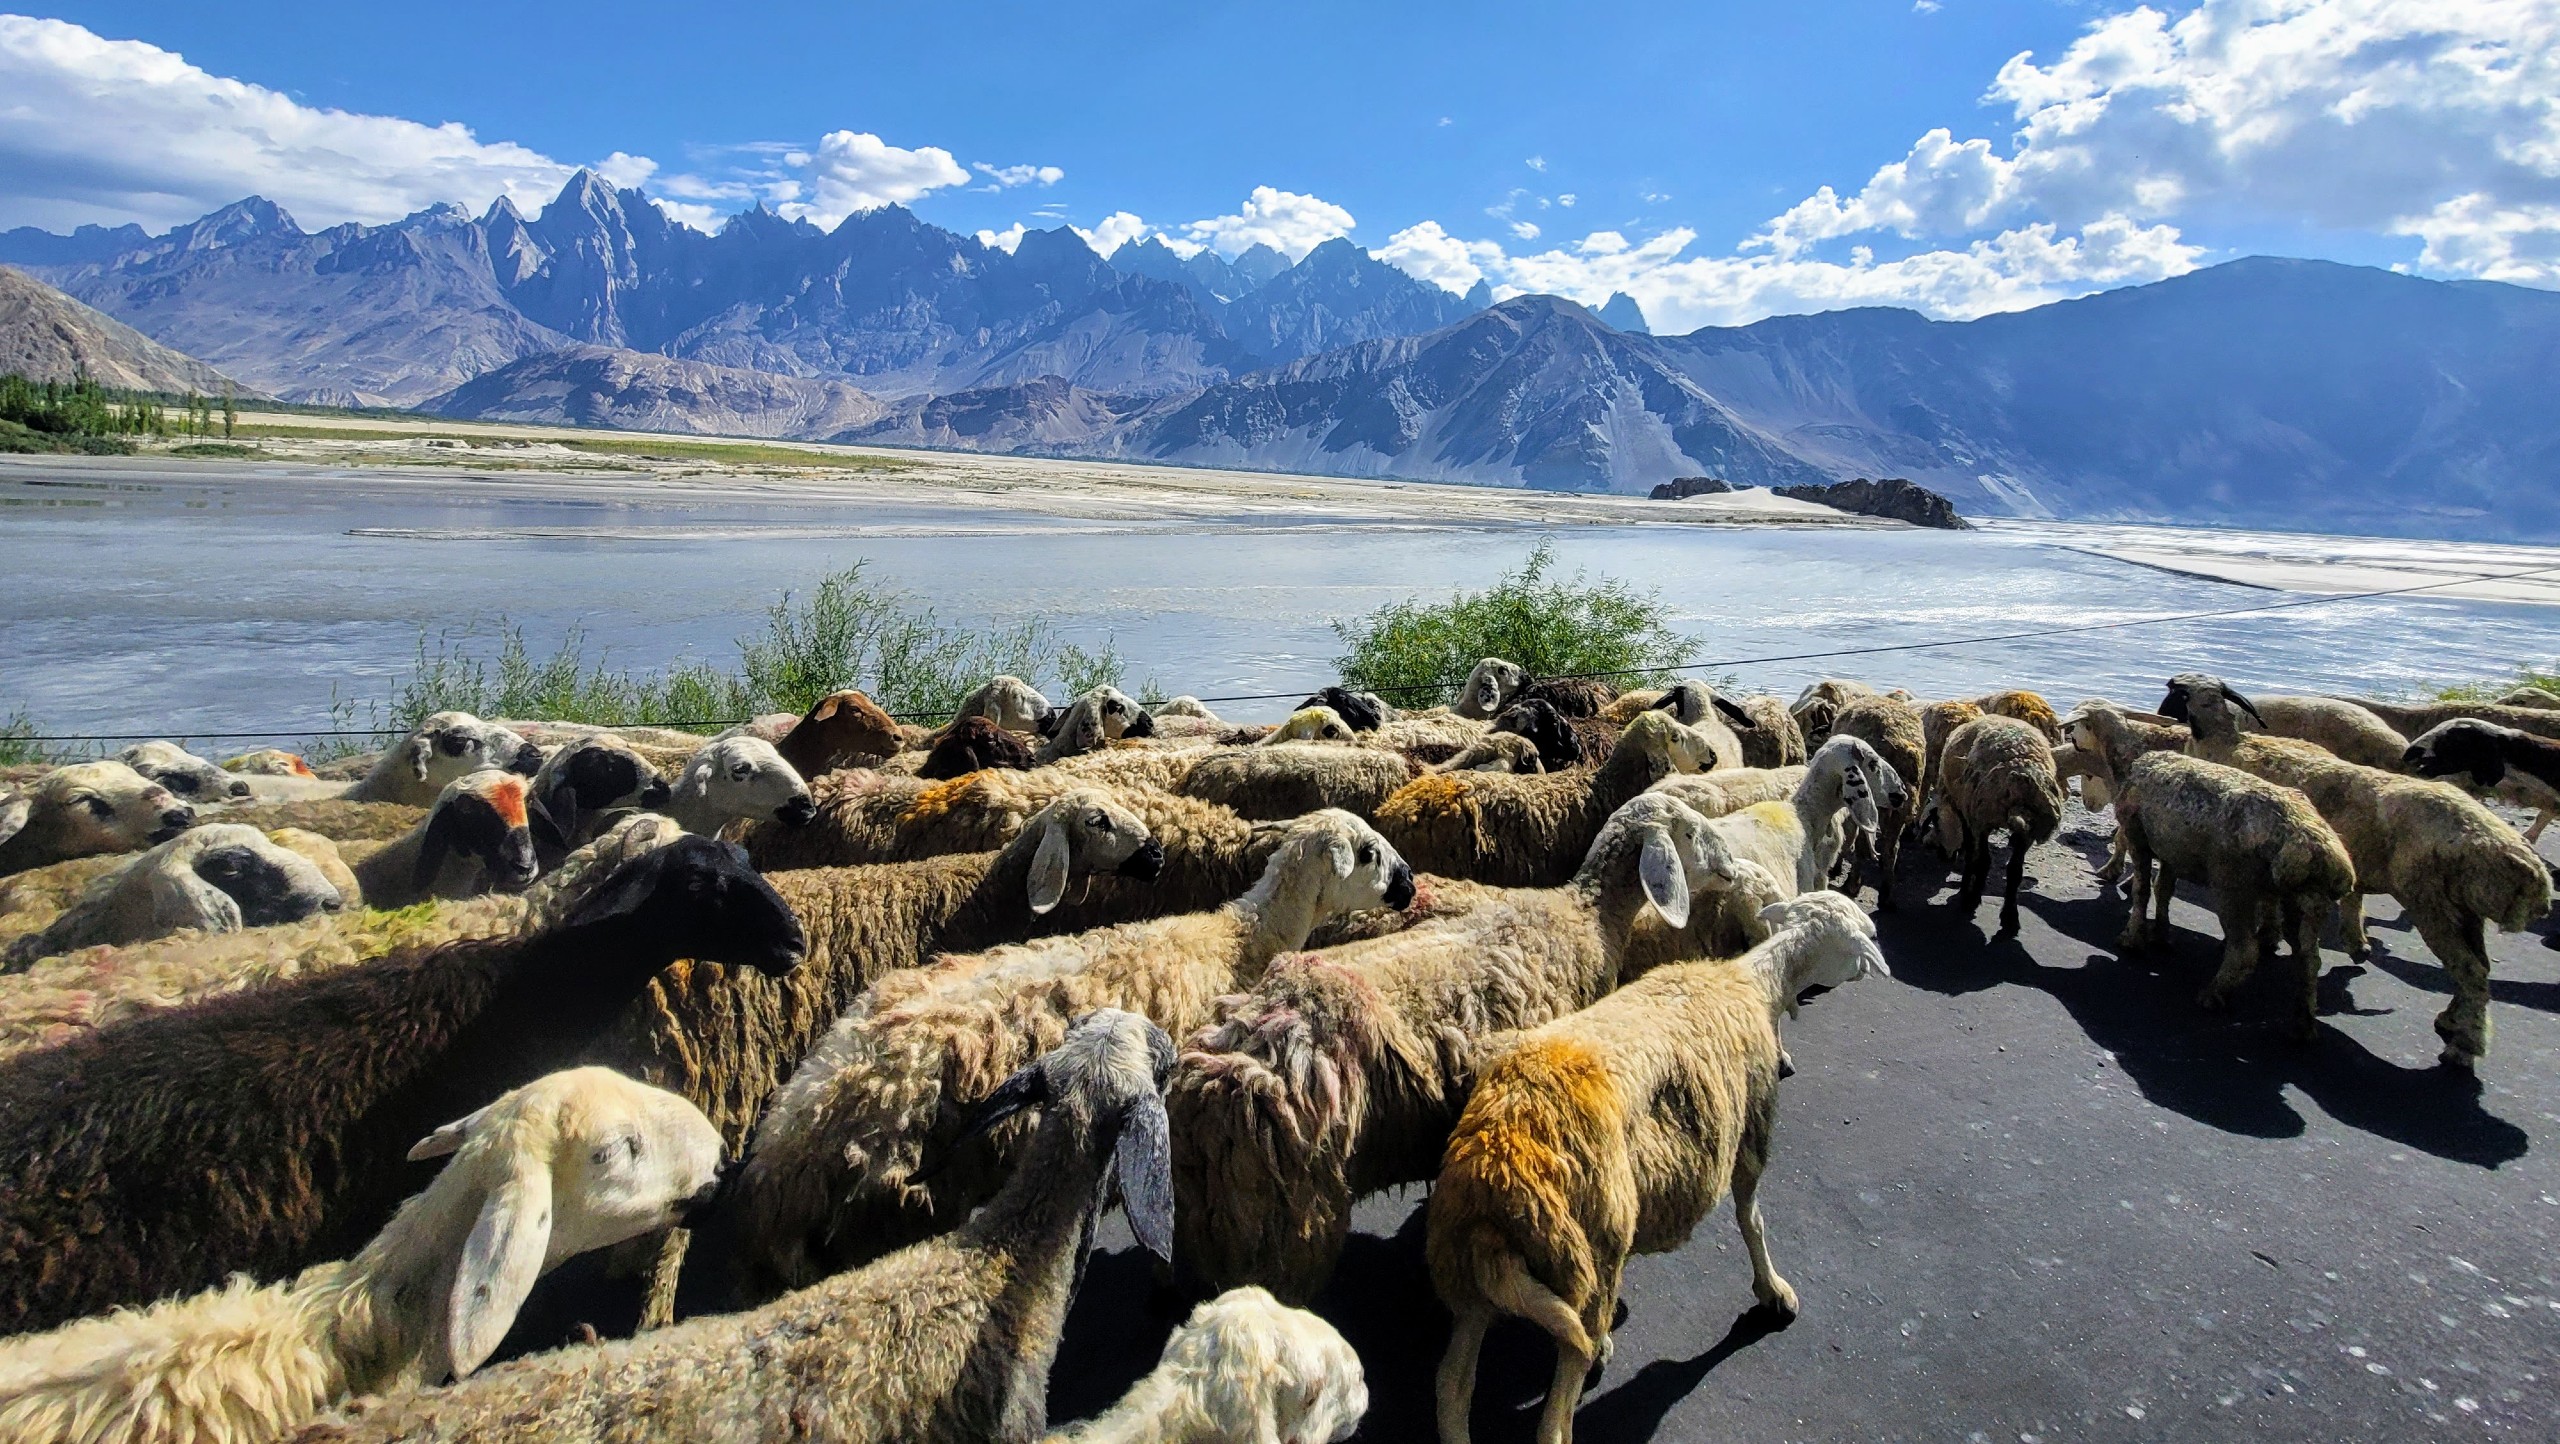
0,172,2560,540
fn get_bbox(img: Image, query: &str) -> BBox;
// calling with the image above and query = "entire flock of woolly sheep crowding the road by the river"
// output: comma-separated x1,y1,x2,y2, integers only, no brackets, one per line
0,658,2560,1444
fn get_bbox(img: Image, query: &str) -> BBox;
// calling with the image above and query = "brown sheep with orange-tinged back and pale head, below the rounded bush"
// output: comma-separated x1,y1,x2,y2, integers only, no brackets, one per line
1377,712,1708,886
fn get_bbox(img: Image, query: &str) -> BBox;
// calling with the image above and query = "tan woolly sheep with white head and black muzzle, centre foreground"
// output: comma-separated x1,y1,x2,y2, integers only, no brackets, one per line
737,812,1413,1296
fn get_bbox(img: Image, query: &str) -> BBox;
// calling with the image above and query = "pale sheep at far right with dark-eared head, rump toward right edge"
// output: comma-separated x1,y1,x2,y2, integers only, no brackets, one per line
2170,673,2552,1070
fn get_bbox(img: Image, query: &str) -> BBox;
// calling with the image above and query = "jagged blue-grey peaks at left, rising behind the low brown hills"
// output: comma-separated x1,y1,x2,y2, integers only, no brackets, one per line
0,172,1495,405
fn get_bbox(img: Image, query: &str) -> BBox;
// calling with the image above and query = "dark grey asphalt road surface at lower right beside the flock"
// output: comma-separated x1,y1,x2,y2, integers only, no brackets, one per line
1050,812,2560,1444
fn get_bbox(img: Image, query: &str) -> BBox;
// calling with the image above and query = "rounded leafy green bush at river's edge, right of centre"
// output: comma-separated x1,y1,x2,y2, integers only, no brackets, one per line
1334,543,1697,707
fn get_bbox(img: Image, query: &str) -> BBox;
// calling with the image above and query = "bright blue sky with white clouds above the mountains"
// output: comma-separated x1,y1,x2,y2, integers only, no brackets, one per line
0,0,2560,330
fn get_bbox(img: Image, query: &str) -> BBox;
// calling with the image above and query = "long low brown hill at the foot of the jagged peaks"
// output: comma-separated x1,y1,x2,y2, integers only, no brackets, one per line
420,346,883,438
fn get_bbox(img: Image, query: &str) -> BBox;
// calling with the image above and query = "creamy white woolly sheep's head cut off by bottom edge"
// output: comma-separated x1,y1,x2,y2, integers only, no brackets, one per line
1050,1288,1370,1444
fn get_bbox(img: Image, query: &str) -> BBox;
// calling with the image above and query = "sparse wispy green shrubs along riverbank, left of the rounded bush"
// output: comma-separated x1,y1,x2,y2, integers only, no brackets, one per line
384,563,1124,730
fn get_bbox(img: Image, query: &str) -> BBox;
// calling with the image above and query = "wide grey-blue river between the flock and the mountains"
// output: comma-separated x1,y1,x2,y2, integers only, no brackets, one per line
0,458,2560,740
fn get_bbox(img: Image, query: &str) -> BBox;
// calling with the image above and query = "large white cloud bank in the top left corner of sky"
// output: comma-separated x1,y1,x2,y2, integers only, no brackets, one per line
0,15,578,230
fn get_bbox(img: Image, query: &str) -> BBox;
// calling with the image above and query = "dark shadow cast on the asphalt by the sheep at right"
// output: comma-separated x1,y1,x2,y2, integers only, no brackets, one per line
1884,853,2527,1167
